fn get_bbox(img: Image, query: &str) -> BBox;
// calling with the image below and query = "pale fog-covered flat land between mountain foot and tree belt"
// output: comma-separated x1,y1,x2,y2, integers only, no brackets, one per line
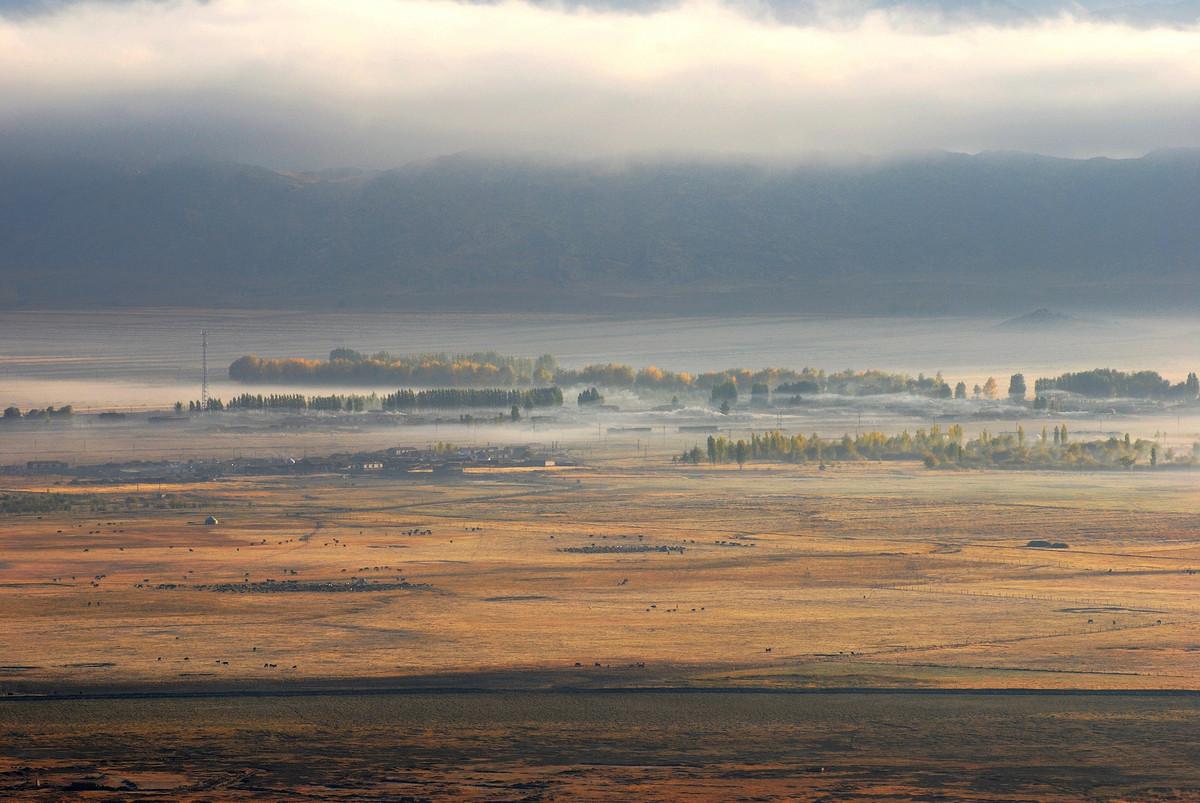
0,310,1200,409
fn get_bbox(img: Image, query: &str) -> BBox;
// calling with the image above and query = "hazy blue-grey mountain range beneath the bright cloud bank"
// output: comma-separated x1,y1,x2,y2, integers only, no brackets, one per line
0,151,1200,313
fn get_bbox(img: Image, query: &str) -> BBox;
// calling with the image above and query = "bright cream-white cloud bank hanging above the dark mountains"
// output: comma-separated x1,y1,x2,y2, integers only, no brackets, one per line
0,0,1200,168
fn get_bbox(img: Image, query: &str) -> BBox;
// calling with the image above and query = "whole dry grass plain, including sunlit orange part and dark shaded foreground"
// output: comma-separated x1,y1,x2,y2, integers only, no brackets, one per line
0,451,1200,801
